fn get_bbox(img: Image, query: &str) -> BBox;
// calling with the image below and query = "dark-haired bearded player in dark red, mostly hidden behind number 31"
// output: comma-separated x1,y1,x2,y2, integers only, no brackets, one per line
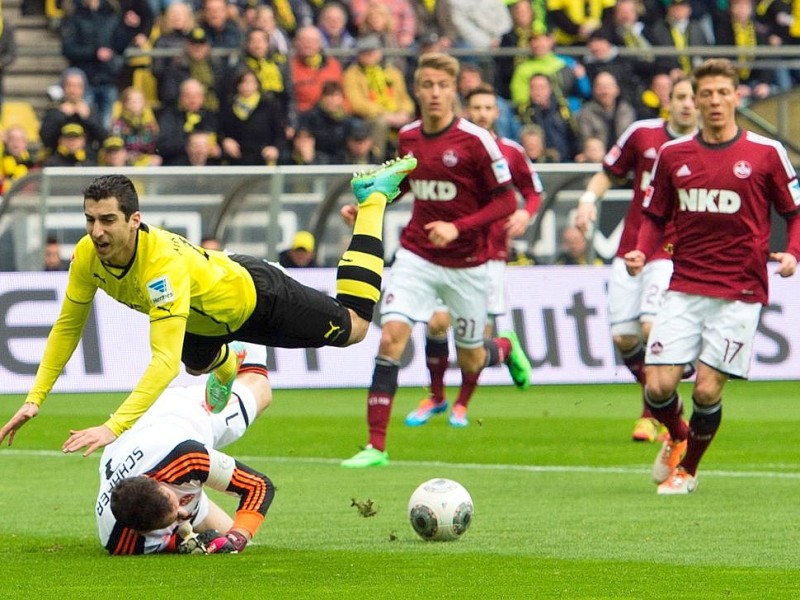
406,83,542,427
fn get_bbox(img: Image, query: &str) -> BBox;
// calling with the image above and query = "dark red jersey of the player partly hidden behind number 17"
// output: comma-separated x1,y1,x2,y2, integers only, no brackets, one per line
603,119,675,260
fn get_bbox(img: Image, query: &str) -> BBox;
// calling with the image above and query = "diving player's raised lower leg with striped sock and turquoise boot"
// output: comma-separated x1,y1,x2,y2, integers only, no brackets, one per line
336,156,417,322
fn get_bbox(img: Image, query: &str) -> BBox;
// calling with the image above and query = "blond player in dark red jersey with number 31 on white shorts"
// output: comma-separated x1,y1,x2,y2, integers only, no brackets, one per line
342,53,530,468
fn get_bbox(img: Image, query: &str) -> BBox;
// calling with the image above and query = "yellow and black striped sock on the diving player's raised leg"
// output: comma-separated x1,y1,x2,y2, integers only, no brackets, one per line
336,192,386,321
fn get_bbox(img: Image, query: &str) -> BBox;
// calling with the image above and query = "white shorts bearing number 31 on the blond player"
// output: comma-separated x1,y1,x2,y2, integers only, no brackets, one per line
381,248,488,348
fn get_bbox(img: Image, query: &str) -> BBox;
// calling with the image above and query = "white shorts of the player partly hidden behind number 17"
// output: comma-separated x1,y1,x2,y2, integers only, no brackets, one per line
608,256,672,336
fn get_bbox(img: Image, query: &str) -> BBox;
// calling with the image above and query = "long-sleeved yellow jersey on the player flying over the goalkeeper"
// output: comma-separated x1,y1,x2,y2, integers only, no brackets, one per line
26,224,256,435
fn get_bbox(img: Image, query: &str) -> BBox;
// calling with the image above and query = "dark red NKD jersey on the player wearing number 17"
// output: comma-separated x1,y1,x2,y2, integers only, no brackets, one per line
640,130,800,304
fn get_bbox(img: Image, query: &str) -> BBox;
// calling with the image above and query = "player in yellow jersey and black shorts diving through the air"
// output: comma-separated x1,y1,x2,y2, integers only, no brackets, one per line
0,157,416,456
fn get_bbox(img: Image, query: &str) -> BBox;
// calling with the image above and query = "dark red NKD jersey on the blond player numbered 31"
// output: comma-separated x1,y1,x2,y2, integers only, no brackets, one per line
398,118,513,268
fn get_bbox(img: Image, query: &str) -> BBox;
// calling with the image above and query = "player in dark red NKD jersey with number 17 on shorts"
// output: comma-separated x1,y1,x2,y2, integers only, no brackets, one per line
625,59,800,494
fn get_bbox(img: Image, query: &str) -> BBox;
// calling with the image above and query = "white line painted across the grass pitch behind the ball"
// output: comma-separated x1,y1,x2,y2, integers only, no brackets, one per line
0,448,800,479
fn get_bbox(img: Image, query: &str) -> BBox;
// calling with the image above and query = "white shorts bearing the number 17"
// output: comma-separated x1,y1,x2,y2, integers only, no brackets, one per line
645,291,761,378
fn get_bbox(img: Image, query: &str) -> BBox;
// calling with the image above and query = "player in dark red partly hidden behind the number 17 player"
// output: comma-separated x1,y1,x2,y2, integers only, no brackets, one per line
575,78,697,442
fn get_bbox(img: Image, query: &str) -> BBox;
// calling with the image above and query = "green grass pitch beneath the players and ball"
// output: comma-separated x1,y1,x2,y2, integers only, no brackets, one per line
0,382,800,600
